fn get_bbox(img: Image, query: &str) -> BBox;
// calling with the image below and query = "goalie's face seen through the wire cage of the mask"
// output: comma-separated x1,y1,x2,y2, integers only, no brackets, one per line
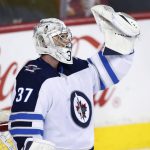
53,33,71,47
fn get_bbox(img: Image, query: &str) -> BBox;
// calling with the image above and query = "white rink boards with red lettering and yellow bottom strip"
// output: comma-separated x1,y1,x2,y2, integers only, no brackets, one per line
0,17,150,150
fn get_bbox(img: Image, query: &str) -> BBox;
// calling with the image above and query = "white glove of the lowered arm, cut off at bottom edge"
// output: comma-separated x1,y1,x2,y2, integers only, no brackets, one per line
22,138,56,150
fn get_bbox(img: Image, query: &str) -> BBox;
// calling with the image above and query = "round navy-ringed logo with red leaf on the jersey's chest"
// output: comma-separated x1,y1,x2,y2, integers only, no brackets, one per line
71,91,92,128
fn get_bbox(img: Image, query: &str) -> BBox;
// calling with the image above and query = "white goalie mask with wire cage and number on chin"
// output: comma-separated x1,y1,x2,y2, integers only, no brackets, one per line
33,18,72,64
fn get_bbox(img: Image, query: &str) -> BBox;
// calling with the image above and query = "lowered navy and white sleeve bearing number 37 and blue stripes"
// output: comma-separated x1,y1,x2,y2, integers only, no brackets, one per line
9,70,50,150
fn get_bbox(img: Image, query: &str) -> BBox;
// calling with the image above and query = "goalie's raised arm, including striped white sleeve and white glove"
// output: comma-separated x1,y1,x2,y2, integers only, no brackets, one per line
88,5,140,91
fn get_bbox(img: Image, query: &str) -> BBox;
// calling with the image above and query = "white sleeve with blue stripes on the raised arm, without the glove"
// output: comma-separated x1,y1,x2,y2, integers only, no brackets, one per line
88,48,134,93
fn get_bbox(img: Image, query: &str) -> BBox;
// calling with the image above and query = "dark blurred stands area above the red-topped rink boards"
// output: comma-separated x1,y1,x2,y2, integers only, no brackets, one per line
0,0,150,25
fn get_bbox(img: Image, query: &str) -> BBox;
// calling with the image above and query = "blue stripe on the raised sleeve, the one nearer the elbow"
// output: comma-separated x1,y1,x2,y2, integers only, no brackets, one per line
98,51,119,83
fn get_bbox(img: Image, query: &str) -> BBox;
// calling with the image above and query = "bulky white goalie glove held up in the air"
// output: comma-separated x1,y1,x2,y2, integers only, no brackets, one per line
91,5,140,55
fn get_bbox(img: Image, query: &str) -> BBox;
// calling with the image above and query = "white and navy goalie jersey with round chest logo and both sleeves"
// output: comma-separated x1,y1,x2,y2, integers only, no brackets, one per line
9,50,133,150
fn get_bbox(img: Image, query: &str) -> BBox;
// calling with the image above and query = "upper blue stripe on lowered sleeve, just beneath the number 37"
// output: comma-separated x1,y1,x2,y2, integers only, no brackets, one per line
9,113,44,121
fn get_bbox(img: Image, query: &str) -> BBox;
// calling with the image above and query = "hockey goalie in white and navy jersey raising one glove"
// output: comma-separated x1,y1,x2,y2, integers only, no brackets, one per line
1,5,140,150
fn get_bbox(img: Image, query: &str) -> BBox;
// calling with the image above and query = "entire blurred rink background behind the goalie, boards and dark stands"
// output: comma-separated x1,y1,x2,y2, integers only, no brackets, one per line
0,0,150,150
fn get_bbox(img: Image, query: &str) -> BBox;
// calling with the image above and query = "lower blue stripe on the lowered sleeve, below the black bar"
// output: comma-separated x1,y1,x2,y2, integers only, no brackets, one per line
10,129,43,136
